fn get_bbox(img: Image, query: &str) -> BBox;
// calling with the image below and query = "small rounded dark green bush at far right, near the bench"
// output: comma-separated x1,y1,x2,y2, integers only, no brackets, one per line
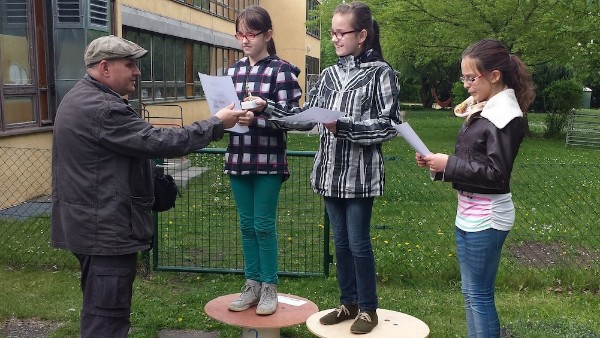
544,80,583,138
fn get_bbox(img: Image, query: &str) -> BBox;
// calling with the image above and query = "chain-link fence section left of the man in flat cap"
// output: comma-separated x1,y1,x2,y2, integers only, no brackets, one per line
0,147,76,266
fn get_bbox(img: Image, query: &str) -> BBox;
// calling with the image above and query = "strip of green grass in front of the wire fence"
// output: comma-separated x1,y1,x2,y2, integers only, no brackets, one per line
0,268,600,338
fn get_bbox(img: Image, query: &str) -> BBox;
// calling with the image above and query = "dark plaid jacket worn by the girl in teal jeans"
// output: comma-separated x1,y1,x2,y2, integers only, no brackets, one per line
224,55,302,178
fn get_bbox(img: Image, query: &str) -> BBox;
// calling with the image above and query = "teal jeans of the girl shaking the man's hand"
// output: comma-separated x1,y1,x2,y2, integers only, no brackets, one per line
229,175,283,284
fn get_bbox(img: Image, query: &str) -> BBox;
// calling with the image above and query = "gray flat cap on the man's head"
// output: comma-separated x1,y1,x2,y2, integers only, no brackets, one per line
83,35,148,68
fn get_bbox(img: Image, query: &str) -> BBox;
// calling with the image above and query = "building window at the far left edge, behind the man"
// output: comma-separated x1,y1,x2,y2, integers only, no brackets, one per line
0,0,52,135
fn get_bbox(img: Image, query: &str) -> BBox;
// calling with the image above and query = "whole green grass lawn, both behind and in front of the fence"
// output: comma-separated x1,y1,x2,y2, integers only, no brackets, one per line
0,110,600,338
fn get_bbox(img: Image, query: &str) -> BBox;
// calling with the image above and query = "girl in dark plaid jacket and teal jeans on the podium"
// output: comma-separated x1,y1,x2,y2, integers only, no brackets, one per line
225,6,302,315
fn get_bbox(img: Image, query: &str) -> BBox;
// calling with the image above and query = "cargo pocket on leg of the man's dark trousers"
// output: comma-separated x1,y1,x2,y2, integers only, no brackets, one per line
93,267,133,316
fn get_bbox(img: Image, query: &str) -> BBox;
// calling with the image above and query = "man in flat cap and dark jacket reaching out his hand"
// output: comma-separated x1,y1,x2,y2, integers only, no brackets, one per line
51,35,244,338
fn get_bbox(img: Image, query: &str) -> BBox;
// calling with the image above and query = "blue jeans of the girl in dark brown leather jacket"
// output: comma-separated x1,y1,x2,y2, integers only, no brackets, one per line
455,228,508,338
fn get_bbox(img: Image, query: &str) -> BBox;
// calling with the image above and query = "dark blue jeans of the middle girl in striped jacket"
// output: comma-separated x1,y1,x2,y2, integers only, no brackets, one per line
324,197,378,311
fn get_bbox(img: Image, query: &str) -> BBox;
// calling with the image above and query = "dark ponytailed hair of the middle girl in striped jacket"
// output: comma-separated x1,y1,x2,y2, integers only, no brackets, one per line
333,1,383,58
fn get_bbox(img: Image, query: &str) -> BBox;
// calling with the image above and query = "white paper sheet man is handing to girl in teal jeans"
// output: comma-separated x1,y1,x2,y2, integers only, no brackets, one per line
198,73,249,134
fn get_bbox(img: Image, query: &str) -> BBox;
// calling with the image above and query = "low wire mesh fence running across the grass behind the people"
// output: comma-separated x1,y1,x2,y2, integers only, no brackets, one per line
0,147,600,280
